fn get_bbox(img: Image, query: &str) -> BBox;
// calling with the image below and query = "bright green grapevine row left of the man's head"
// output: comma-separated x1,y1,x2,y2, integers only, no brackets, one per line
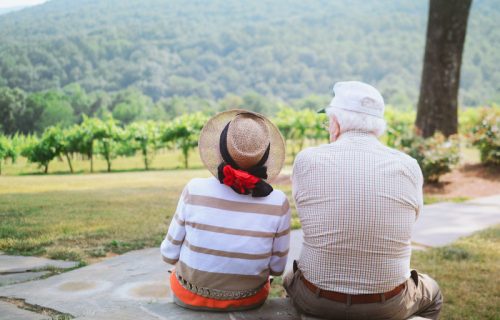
0,107,328,173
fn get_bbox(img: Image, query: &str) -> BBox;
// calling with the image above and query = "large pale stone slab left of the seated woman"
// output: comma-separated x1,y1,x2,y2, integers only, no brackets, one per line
0,248,171,319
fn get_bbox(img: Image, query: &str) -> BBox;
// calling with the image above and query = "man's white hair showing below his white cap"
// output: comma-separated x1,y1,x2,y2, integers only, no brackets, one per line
327,108,386,137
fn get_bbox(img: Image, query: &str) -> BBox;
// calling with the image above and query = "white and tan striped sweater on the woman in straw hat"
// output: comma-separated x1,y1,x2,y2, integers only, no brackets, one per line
160,177,290,290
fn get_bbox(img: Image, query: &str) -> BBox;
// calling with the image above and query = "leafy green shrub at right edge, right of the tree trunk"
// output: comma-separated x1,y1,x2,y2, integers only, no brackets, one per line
468,106,500,166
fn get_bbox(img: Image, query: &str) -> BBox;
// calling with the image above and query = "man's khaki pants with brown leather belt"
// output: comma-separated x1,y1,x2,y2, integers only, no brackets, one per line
283,270,443,320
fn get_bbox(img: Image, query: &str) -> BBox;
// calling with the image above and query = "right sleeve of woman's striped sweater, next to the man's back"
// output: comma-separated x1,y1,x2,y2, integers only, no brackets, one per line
269,198,291,276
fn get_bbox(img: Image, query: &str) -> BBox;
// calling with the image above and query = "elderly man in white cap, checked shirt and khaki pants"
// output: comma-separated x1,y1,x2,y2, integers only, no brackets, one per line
284,81,442,319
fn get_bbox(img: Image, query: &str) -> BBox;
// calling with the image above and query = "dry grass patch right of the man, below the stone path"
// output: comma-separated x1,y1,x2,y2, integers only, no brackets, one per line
271,225,500,320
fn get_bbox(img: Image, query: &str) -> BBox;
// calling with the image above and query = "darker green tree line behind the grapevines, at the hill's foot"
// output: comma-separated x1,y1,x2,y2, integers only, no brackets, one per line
0,84,334,135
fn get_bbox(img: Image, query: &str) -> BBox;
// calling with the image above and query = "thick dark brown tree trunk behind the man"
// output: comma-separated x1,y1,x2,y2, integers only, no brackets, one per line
415,0,472,137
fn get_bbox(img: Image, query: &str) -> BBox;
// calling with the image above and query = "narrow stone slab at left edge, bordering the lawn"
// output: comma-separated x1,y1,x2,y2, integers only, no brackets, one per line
0,255,78,273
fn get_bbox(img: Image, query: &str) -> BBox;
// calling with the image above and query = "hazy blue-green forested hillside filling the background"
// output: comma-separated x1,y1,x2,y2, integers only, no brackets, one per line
0,0,500,105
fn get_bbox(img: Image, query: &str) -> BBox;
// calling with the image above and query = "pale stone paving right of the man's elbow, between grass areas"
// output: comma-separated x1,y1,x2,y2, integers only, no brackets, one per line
412,195,500,246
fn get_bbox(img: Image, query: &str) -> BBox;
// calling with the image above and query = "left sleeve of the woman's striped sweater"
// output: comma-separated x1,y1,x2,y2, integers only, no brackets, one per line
160,186,188,264
